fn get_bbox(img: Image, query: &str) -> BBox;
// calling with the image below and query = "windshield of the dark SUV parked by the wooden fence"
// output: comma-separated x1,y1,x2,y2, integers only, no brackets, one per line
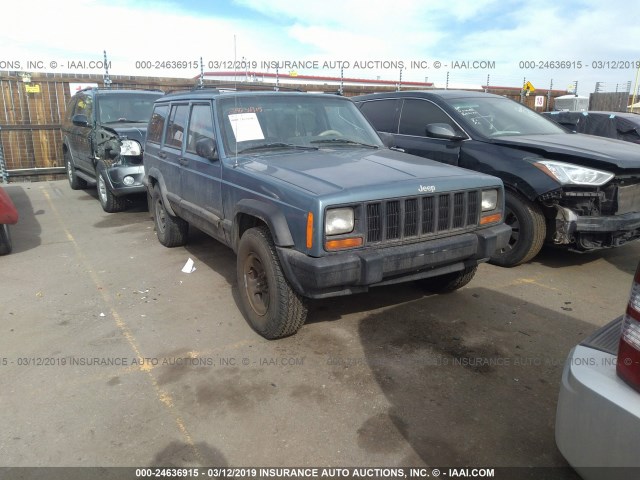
98,92,161,123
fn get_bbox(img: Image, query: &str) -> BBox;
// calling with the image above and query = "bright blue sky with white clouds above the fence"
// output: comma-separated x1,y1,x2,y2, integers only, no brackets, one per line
0,0,640,94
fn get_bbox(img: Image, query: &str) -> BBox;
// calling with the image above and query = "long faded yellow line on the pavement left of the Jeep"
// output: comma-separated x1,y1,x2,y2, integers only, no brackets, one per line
40,186,205,465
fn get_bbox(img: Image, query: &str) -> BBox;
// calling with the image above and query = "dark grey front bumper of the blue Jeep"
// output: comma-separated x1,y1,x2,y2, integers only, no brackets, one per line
277,224,511,298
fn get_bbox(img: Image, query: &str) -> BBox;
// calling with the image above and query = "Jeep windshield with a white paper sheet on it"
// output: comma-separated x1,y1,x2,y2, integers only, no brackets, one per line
218,93,382,155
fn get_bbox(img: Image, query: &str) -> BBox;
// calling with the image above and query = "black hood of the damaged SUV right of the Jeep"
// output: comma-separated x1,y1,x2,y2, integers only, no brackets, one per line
491,133,640,171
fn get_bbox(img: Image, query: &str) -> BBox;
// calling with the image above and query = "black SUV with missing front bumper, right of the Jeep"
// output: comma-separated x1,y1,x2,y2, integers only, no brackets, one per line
353,90,640,267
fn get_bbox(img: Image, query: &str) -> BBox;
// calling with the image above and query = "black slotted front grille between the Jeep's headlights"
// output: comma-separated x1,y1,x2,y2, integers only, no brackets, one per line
365,190,480,243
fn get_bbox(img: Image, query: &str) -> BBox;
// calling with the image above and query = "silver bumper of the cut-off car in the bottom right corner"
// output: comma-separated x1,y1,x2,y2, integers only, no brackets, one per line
555,318,640,480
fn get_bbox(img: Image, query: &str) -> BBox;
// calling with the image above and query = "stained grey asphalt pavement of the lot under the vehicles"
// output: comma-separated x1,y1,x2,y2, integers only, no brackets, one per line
0,181,640,478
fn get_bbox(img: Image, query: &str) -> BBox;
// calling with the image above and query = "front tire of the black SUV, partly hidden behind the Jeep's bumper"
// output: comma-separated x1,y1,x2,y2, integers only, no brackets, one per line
489,192,547,267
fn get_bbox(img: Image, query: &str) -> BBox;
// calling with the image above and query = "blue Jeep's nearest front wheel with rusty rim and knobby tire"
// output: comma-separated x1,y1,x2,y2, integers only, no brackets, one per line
236,227,307,340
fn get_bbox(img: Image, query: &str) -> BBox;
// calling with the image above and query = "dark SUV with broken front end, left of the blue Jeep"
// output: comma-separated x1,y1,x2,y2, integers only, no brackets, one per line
62,88,163,213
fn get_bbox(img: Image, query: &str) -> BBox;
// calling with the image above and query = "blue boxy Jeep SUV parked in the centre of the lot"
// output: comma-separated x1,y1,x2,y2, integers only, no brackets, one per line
144,89,510,338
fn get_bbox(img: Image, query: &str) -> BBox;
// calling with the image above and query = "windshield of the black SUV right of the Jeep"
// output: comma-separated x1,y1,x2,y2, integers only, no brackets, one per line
447,97,567,137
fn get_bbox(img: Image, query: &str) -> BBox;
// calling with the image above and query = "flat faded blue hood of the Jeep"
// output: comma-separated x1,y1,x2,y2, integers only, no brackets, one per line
232,148,501,198
